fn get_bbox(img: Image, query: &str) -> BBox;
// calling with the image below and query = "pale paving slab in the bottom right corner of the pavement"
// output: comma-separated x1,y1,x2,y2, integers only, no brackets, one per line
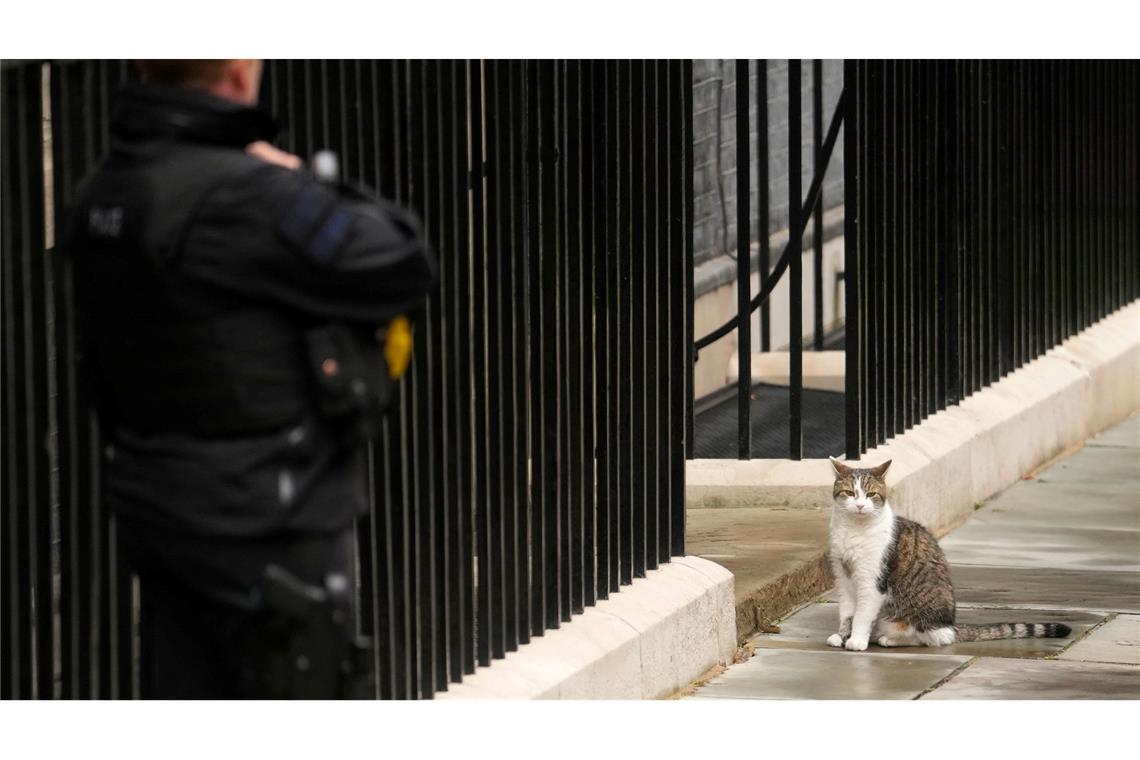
922,657,1140,700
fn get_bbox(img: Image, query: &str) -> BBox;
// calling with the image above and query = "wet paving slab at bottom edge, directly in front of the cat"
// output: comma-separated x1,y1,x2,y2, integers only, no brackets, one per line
690,649,970,700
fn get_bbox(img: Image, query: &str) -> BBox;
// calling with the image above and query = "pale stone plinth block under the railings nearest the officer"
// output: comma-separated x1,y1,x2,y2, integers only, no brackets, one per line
437,557,735,700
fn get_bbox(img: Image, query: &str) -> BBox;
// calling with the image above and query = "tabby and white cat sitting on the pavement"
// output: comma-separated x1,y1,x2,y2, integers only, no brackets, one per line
828,458,1070,652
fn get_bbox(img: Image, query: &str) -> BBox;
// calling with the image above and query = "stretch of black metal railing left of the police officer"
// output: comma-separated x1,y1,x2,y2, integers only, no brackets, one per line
0,62,135,698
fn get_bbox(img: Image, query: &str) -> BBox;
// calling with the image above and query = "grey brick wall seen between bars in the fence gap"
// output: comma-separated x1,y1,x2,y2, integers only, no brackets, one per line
693,59,844,264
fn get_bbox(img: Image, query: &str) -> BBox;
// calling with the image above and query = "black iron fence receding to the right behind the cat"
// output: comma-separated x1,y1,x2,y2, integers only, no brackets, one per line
845,60,1140,458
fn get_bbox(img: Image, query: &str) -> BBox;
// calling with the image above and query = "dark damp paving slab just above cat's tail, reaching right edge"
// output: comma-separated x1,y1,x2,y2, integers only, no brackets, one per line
950,565,1140,613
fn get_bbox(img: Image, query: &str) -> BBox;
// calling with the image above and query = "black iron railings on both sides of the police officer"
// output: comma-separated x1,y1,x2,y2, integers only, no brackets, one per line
0,60,692,698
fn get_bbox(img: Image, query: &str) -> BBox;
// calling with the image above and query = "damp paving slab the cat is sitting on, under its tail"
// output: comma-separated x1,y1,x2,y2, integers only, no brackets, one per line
749,603,1104,659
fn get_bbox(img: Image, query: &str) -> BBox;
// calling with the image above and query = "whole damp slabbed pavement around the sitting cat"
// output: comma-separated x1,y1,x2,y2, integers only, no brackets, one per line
687,415,1140,700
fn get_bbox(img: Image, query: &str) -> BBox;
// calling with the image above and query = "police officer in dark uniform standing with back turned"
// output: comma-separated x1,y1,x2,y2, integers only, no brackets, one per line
63,60,434,698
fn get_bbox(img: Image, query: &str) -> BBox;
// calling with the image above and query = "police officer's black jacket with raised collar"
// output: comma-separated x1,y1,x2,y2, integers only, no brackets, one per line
62,85,434,536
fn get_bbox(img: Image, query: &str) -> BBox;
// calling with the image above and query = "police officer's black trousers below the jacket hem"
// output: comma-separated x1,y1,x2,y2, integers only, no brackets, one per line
120,521,355,700
